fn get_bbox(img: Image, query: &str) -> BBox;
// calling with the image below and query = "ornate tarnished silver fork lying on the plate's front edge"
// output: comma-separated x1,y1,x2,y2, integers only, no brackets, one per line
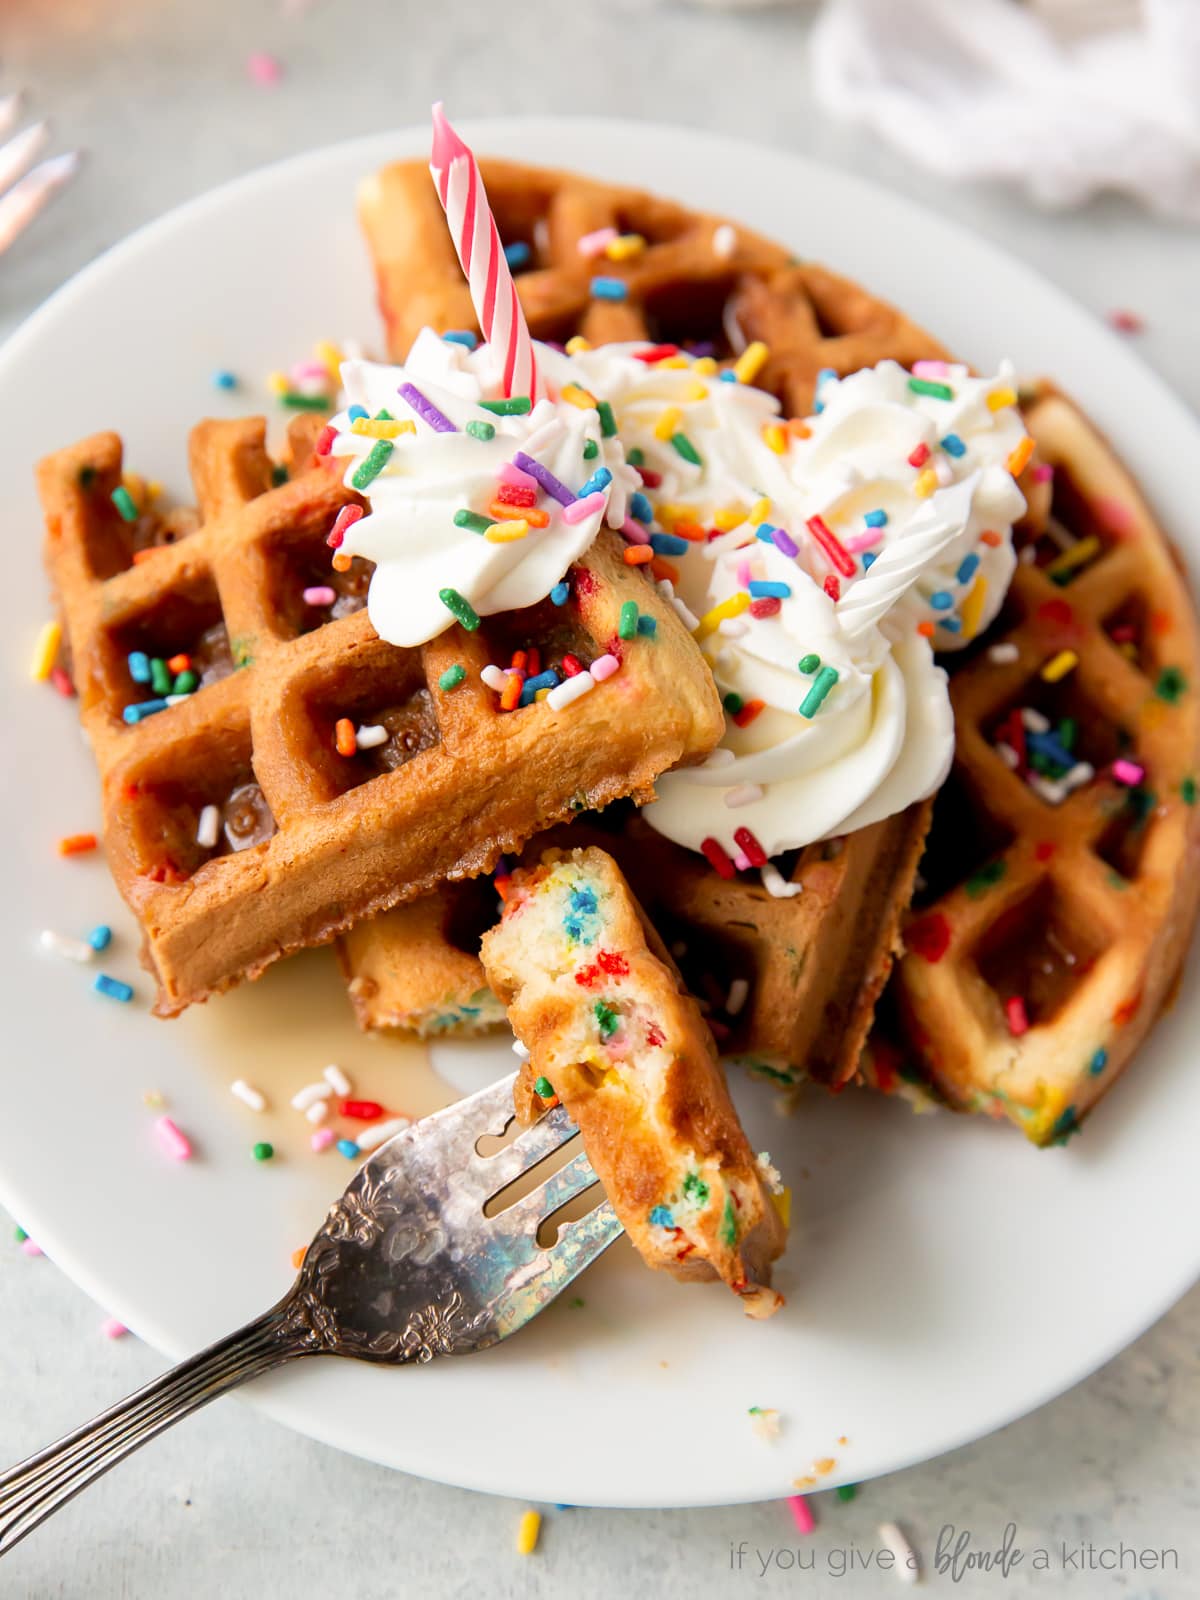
0,1074,621,1555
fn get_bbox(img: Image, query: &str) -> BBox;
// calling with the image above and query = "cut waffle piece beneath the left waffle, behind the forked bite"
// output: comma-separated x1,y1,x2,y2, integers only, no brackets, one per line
339,802,931,1088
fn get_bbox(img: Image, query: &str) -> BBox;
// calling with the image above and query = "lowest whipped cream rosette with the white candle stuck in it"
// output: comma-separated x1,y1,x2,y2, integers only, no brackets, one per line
646,480,976,866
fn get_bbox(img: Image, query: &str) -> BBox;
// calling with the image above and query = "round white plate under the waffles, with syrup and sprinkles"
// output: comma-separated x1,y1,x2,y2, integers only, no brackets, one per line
0,118,1200,1506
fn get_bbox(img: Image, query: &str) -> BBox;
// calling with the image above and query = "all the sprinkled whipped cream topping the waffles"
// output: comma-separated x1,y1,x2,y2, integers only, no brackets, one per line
333,330,1029,867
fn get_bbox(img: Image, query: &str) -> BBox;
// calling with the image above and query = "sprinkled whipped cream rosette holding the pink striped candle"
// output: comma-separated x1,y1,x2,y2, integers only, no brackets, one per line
330,330,642,645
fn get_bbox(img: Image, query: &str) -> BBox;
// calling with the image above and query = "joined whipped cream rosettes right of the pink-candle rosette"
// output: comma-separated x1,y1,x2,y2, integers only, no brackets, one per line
550,346,1032,872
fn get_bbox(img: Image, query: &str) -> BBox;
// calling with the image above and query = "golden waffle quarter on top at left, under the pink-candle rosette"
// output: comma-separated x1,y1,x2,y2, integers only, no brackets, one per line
38,418,722,1014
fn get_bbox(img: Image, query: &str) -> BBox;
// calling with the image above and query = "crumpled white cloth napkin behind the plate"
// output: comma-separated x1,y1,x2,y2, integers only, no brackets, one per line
811,0,1200,222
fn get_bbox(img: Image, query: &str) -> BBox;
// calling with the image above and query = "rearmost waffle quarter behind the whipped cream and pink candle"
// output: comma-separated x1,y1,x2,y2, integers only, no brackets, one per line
358,160,946,416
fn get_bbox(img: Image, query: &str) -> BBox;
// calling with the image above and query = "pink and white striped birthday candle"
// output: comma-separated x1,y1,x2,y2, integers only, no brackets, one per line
429,101,539,405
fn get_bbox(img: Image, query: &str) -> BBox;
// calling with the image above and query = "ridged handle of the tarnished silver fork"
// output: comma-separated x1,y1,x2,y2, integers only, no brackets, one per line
0,1307,309,1555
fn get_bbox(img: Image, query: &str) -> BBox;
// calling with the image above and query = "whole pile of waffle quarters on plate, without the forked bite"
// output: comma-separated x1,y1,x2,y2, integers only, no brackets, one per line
38,152,1200,1142
